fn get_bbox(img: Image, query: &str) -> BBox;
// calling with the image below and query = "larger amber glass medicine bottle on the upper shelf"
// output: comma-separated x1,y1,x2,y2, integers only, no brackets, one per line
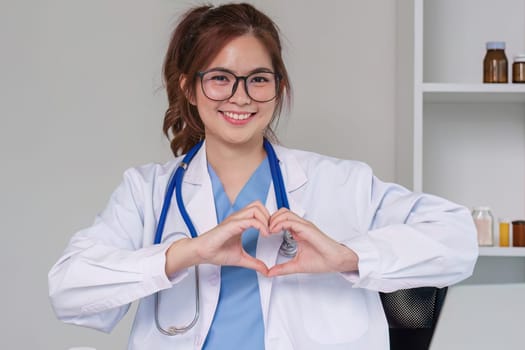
483,41,508,83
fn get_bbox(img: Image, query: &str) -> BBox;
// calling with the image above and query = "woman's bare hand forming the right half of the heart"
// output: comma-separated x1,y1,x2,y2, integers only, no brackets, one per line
268,208,358,277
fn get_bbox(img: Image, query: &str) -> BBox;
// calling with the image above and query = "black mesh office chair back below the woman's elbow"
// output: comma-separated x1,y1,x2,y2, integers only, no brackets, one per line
380,287,447,350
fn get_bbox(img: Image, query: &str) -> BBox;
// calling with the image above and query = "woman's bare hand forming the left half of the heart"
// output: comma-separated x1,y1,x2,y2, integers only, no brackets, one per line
166,201,270,276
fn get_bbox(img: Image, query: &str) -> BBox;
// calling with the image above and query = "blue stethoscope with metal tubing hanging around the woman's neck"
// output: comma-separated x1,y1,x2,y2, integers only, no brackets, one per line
154,139,297,336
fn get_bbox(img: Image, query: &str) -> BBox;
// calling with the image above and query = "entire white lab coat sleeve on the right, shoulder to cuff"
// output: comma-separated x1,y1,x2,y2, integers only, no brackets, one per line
342,171,478,292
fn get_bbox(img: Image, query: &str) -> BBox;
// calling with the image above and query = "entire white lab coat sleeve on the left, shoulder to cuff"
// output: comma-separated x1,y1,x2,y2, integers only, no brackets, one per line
48,169,184,332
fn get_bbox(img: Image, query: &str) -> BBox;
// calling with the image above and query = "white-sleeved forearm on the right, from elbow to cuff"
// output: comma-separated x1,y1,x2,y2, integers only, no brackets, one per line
345,209,477,291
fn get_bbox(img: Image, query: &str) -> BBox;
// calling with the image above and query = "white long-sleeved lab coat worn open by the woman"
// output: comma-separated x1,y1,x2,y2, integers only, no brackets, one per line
49,146,478,350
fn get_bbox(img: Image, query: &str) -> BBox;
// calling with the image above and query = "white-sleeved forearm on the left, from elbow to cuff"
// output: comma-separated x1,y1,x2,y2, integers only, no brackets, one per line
48,239,172,319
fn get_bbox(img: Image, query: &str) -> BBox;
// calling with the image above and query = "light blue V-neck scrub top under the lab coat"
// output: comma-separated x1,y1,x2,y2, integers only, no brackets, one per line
203,158,271,350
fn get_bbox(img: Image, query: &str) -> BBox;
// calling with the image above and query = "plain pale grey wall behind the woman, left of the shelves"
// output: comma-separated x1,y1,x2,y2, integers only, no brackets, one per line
0,0,395,350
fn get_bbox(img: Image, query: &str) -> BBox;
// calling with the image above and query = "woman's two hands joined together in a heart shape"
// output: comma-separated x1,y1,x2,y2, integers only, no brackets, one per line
198,202,358,277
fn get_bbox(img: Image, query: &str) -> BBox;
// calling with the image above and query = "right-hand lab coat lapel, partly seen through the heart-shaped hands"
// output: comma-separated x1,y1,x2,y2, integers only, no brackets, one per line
257,146,307,324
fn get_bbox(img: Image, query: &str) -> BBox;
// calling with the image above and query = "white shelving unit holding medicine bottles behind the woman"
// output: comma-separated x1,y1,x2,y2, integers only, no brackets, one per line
396,0,525,283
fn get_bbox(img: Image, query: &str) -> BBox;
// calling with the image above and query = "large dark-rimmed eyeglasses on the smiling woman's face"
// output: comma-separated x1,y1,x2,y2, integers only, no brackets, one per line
197,68,280,102
